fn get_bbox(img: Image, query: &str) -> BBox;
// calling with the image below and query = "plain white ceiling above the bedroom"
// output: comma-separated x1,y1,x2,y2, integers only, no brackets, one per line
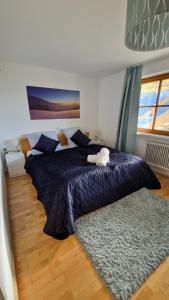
0,0,169,76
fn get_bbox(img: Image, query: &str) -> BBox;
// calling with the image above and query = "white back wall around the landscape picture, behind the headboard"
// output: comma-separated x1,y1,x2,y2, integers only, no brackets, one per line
0,63,99,147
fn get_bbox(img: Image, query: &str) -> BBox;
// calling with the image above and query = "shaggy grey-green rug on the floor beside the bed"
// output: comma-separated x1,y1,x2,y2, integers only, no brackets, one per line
76,188,169,300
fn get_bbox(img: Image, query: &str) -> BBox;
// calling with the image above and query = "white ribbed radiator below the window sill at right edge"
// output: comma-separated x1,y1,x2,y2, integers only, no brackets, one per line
145,142,169,170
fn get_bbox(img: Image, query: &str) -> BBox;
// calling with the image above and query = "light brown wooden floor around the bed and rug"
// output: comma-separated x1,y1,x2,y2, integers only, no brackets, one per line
7,176,169,300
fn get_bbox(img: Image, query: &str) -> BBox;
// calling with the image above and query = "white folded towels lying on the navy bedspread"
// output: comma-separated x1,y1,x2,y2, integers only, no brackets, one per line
87,148,110,167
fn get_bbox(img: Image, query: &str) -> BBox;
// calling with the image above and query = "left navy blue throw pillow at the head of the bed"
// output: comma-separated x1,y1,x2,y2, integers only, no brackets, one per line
32,134,59,153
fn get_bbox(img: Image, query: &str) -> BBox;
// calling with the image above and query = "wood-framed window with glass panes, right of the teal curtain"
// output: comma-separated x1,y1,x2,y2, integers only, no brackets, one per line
137,74,169,135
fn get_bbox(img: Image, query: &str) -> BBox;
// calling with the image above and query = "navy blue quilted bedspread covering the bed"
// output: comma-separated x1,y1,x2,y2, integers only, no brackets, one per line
25,145,160,239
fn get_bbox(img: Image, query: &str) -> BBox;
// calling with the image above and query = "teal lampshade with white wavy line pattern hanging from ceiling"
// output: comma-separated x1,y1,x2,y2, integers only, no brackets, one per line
125,0,169,51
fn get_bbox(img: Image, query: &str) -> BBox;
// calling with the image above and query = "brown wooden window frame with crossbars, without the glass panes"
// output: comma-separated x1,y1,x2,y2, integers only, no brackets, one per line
137,73,169,136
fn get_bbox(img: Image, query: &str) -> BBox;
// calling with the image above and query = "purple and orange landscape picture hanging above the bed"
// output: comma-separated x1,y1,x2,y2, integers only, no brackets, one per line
26,86,80,120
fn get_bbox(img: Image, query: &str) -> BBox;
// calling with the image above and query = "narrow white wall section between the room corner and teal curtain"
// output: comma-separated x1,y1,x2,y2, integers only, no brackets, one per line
98,72,125,146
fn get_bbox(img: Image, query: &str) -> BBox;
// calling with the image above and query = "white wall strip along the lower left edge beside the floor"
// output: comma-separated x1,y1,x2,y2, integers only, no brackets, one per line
0,158,18,300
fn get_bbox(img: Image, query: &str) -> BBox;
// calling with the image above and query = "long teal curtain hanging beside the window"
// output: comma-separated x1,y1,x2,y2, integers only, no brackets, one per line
116,66,142,153
